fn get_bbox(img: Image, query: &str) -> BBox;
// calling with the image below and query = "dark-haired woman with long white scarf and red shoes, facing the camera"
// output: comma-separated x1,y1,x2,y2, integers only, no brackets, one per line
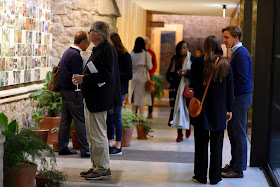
166,41,194,142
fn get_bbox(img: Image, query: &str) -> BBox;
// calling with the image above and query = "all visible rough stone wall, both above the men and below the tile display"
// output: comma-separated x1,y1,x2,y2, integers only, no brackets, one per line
0,0,120,128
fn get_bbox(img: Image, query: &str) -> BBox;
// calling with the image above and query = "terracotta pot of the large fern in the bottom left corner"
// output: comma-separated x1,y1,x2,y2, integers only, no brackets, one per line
4,163,37,187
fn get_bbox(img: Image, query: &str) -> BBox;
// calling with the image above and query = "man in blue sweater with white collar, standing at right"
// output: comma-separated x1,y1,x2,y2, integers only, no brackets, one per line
222,26,253,178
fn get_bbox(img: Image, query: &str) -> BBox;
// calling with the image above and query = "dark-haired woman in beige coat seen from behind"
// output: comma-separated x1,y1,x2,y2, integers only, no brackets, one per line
129,37,153,115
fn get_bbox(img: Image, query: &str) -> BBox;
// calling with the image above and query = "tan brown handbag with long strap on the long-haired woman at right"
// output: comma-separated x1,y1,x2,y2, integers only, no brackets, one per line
188,57,220,117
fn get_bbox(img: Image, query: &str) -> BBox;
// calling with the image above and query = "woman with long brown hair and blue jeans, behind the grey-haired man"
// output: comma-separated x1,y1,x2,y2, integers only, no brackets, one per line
106,33,132,155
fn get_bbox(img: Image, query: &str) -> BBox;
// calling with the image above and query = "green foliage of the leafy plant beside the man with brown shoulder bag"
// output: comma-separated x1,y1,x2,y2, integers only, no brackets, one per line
29,71,62,117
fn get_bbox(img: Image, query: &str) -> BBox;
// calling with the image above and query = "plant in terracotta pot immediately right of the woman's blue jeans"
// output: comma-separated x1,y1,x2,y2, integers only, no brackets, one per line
122,107,136,147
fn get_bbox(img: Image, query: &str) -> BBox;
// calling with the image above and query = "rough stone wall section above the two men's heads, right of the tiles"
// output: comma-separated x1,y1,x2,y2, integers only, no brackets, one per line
52,0,120,64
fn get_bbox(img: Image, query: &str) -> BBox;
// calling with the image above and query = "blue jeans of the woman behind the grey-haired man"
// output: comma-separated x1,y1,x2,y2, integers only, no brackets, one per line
106,95,125,141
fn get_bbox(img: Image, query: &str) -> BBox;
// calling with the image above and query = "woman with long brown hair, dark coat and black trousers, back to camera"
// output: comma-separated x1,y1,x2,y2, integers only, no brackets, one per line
191,36,233,184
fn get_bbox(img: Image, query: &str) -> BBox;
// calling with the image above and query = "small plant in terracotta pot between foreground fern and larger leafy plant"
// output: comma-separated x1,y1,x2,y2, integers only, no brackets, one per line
32,109,49,142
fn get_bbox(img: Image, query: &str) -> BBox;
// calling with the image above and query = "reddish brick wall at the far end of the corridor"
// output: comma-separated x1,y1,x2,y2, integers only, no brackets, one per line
153,14,230,53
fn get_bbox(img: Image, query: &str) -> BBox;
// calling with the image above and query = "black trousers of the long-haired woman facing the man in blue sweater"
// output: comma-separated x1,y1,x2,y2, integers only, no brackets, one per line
194,125,224,183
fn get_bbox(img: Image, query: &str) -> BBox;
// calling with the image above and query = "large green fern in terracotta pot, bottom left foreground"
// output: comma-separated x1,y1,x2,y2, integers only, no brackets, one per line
0,113,55,187
